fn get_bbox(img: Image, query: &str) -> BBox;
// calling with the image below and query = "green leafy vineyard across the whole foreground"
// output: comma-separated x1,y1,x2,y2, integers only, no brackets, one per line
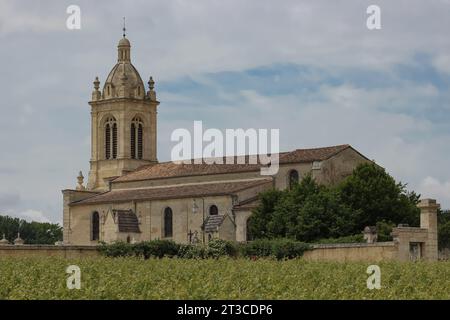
0,257,450,299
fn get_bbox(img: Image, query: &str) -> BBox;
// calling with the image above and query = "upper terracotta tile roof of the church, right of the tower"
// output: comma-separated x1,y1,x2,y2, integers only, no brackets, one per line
113,144,350,183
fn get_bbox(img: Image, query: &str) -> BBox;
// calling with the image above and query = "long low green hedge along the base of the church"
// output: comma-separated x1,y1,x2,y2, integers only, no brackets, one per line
99,239,308,260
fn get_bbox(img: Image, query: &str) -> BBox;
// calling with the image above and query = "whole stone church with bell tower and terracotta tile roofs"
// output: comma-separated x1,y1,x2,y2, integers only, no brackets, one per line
62,35,370,245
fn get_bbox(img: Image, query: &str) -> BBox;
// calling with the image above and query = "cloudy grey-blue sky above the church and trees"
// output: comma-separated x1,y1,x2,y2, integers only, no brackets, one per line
0,0,450,222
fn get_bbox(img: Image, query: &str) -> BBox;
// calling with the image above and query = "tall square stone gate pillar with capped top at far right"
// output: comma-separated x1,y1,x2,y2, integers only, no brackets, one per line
417,199,440,261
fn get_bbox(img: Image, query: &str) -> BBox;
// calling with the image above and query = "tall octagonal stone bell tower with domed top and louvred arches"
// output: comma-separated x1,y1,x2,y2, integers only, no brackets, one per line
87,28,159,191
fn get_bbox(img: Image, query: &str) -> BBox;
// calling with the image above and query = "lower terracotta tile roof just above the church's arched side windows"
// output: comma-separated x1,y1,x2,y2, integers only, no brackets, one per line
71,178,272,205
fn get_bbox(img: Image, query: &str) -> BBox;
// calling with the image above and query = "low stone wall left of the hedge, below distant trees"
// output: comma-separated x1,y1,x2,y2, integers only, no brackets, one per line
0,244,100,259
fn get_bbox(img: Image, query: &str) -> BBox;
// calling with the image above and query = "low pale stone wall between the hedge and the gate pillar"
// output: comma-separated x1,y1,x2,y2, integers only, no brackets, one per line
303,241,398,262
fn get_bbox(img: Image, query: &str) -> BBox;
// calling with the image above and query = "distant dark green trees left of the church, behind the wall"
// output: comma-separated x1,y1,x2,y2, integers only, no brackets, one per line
0,216,62,244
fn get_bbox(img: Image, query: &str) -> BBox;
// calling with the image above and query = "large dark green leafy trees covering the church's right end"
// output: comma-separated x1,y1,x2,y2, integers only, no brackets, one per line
248,163,420,242
